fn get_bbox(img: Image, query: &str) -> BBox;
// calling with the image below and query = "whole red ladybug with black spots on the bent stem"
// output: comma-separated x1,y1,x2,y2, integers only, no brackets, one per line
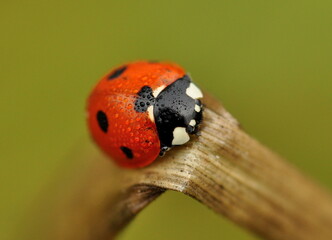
87,61,203,168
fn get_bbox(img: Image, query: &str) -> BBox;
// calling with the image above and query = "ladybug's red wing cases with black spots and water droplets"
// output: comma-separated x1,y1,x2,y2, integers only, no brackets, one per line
87,61,185,168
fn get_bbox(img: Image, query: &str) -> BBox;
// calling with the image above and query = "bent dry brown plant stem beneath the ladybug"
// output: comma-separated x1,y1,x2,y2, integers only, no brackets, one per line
43,94,332,240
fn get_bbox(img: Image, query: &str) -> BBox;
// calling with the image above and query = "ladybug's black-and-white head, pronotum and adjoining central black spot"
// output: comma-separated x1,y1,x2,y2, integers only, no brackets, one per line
135,75,203,155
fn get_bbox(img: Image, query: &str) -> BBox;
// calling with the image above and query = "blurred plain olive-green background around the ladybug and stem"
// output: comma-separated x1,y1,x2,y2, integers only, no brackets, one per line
0,0,332,240
